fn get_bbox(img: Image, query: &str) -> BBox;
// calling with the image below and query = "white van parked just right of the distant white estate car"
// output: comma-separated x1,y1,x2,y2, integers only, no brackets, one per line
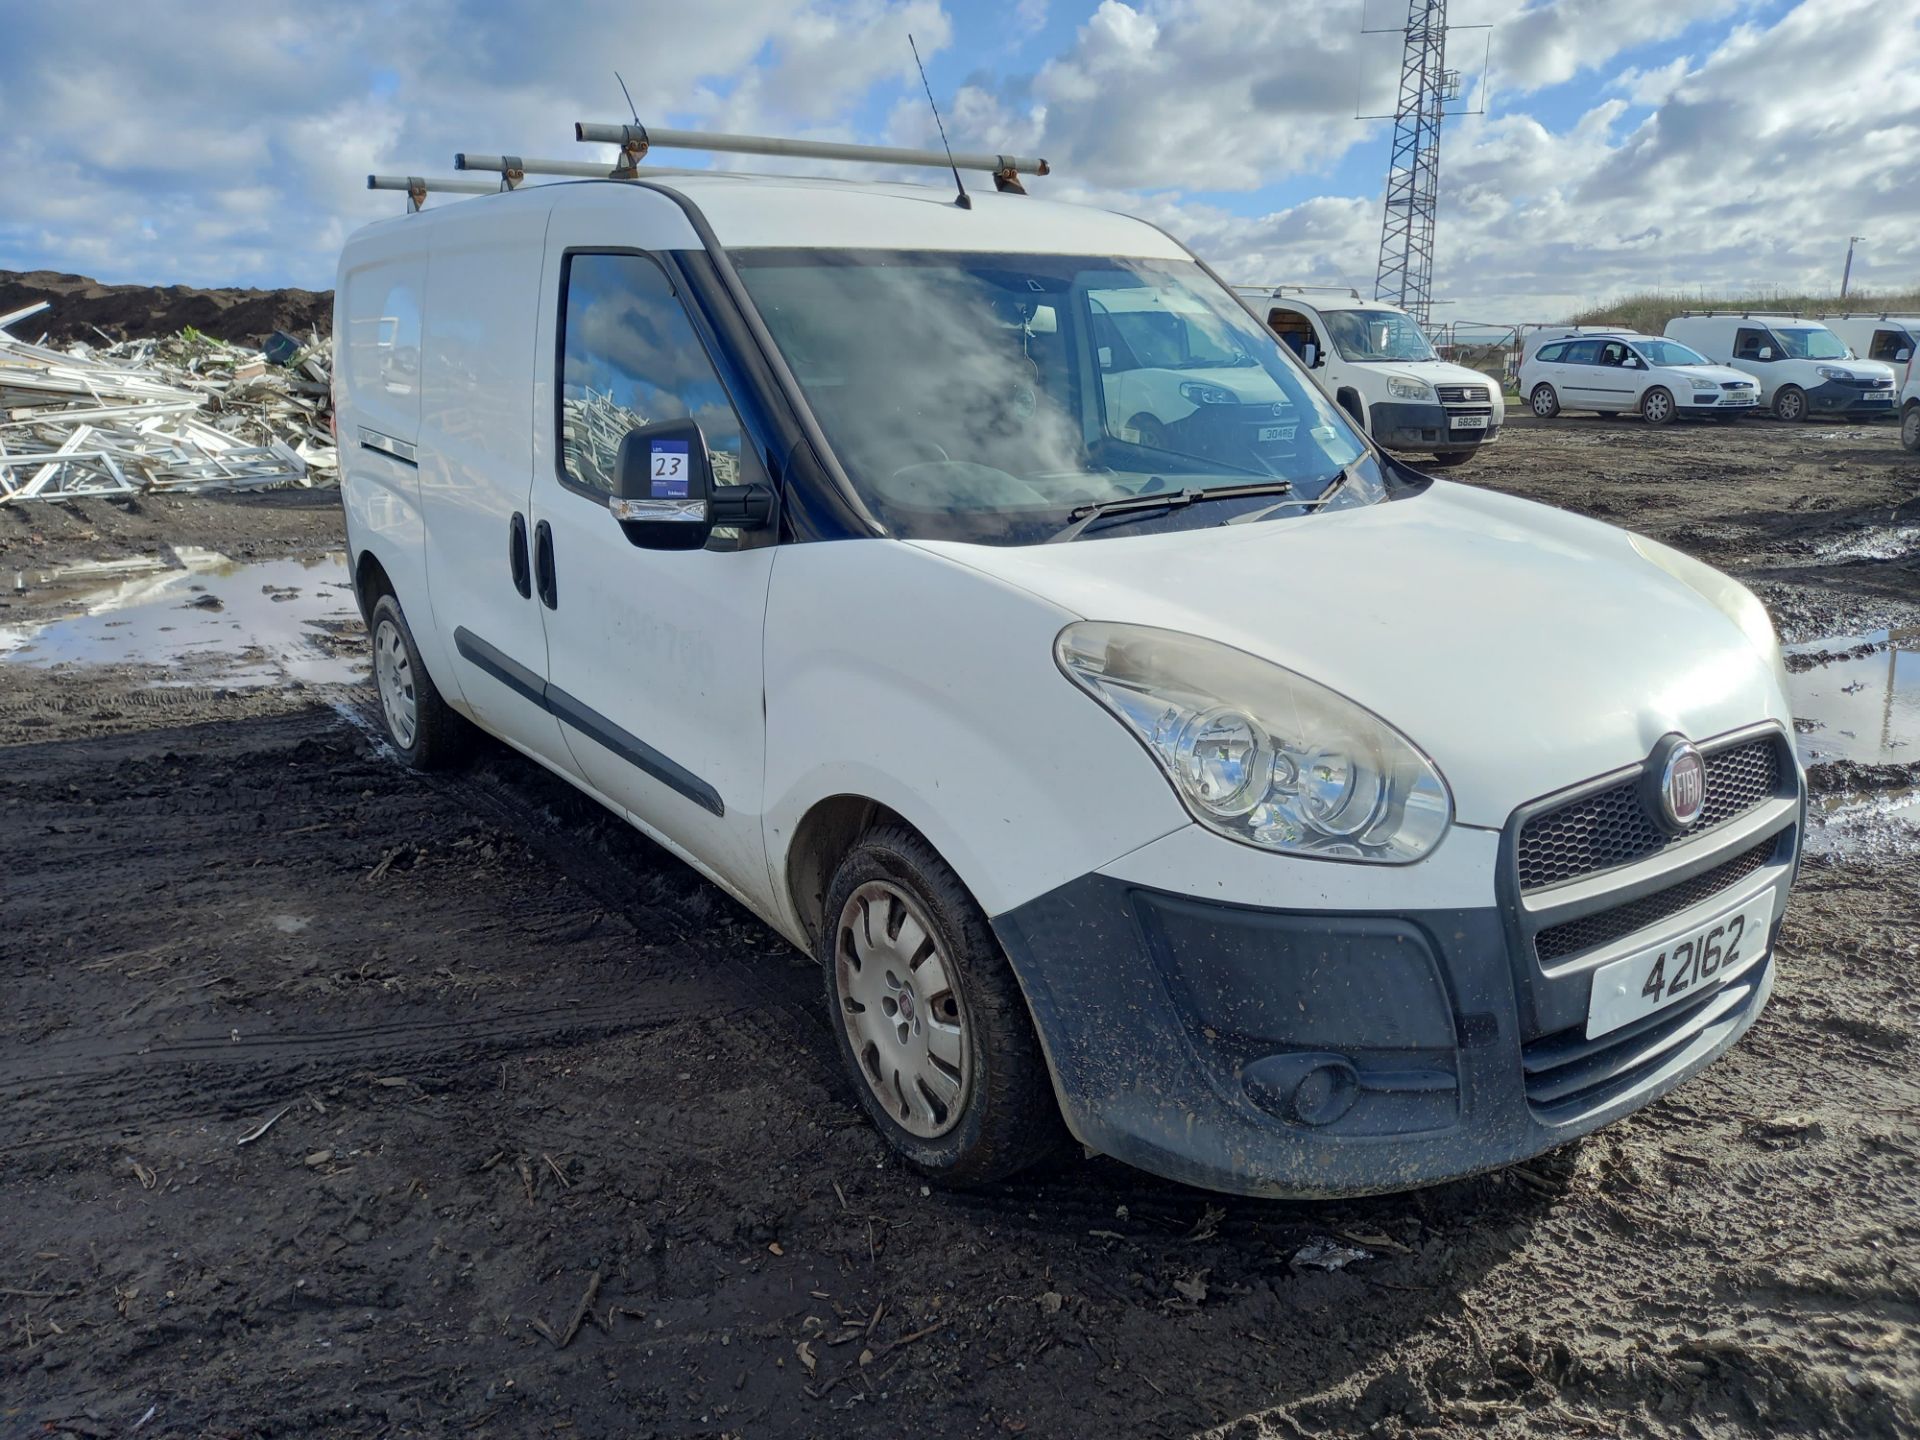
1667,315,1895,420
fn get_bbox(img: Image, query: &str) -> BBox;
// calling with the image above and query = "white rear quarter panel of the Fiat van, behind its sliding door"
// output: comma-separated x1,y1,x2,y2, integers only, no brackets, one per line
334,227,447,664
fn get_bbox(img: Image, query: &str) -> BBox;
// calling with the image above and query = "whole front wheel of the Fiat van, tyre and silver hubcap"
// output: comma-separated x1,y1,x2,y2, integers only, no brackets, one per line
820,826,1066,1185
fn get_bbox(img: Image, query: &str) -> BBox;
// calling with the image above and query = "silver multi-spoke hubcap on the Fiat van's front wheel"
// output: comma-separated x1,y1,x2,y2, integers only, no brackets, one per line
833,881,973,1140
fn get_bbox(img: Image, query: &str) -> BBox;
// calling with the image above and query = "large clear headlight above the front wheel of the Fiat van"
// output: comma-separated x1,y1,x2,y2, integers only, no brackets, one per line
1054,620,1453,864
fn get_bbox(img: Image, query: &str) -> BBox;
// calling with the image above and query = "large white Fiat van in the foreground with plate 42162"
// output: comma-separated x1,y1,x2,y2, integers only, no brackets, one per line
334,135,1803,1196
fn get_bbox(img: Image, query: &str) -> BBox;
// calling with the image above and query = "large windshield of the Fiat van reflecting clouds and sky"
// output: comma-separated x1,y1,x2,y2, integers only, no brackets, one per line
733,250,1386,545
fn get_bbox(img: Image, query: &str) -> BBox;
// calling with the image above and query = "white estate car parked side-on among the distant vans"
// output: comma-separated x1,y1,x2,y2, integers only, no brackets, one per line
1521,330,1761,424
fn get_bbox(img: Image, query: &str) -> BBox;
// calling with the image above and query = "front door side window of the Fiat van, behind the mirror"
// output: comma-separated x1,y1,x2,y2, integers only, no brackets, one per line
557,255,766,497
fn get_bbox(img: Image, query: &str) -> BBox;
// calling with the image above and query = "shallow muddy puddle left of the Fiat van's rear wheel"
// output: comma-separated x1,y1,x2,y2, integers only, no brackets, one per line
0,547,367,687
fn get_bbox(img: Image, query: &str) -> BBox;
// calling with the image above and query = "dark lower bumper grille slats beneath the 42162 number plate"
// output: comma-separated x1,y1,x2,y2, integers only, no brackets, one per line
1521,954,1774,1123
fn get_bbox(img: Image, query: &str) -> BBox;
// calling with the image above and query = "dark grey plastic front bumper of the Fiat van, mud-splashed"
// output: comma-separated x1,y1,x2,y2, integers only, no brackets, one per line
995,876,1788,1196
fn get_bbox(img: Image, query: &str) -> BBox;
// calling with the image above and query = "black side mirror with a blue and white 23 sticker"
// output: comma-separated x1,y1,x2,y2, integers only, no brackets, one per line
607,420,774,549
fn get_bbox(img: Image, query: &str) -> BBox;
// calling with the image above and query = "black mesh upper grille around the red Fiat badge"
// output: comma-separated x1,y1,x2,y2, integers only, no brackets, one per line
1515,735,1782,891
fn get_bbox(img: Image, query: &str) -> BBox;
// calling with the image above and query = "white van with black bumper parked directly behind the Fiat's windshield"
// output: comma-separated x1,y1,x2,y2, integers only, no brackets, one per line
1238,284,1507,474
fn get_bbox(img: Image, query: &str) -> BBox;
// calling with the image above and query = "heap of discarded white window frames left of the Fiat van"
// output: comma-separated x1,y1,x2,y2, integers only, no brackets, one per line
0,301,338,505
